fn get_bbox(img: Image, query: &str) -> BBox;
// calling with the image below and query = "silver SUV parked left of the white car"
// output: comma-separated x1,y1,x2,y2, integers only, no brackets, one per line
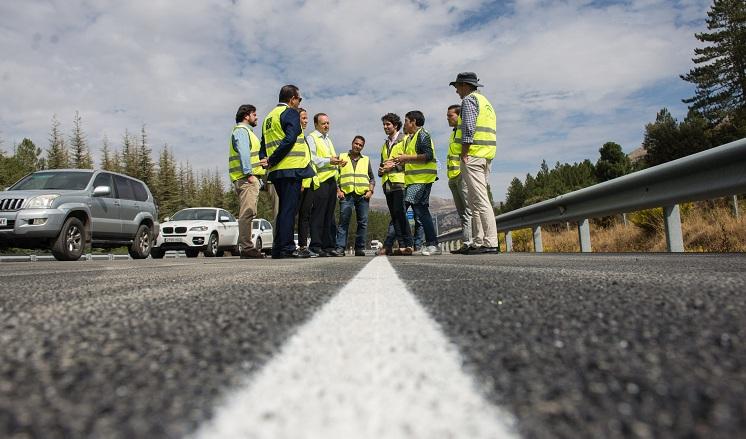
0,169,159,261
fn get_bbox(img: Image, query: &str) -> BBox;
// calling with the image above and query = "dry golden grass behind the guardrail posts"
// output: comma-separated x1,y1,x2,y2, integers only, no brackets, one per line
500,202,746,253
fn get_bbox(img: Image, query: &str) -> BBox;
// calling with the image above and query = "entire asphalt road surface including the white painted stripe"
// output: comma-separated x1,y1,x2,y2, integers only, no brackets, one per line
0,254,746,439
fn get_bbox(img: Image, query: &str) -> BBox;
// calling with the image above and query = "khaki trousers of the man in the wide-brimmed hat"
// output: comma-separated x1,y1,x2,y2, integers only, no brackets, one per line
461,156,499,247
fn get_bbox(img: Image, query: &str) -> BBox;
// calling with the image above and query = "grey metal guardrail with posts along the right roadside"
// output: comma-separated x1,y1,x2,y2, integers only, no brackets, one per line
438,139,746,252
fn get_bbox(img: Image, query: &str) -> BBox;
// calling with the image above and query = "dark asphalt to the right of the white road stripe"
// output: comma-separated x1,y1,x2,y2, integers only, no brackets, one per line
392,254,746,438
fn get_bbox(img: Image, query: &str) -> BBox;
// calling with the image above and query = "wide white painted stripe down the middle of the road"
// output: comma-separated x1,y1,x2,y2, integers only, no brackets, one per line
196,257,517,439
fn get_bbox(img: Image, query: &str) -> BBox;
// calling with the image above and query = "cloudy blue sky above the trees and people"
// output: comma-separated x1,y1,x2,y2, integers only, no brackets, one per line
0,0,711,199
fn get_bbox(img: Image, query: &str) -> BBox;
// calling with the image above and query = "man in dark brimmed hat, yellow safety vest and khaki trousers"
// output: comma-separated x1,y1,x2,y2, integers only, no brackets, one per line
450,72,500,254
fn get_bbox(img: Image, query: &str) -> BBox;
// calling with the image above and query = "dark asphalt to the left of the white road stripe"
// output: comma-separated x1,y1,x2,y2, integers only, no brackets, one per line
0,258,370,439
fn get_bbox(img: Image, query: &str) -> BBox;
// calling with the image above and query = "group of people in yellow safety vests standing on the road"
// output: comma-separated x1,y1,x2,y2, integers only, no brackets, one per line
228,72,499,259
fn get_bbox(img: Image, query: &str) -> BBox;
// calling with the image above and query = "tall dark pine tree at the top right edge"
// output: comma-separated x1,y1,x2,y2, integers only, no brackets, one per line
681,0,746,125
